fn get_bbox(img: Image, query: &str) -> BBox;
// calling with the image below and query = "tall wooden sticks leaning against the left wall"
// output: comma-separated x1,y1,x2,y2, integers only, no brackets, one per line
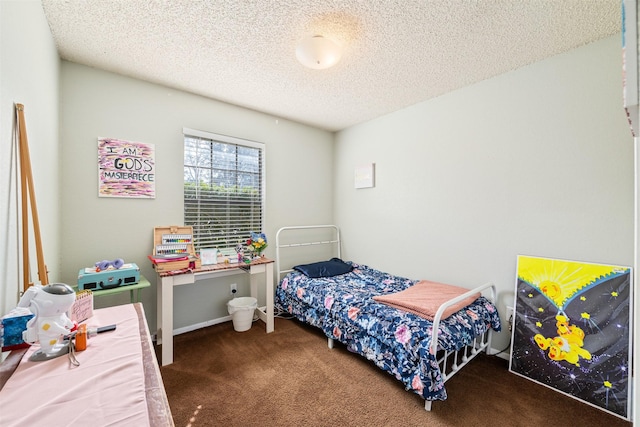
16,104,49,291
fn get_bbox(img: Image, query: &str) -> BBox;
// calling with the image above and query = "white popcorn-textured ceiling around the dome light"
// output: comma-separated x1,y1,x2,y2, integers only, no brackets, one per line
42,0,621,131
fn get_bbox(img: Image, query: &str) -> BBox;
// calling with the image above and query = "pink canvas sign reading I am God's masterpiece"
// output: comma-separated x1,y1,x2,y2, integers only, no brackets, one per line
98,138,156,199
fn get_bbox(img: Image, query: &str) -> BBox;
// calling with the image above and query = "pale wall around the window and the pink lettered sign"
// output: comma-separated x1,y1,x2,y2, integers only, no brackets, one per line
60,61,333,332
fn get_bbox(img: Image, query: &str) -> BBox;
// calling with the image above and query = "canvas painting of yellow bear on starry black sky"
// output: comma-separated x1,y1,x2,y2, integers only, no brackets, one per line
509,256,632,419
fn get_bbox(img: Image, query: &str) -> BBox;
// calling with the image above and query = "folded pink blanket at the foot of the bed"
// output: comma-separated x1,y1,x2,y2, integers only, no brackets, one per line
373,280,480,320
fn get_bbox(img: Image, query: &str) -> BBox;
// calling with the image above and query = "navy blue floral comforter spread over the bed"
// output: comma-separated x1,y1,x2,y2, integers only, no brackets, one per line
275,263,500,400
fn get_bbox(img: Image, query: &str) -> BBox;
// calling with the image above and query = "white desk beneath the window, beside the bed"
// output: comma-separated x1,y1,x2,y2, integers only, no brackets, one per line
156,258,273,366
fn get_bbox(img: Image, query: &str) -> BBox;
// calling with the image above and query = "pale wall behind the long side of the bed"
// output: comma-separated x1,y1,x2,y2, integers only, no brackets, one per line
334,36,634,354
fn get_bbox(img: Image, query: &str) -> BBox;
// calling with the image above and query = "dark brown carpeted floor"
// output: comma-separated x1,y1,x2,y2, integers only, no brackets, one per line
161,318,632,427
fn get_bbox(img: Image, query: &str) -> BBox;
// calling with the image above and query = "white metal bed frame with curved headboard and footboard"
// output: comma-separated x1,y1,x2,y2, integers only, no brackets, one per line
276,225,496,411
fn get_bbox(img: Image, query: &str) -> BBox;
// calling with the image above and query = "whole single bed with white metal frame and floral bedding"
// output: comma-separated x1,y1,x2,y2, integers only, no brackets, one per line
275,225,501,411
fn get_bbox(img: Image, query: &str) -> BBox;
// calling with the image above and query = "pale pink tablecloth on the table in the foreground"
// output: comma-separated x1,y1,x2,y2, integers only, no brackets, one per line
0,304,150,427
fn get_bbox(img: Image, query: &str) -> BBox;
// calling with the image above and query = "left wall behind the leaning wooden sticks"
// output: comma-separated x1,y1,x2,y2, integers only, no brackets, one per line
0,0,60,315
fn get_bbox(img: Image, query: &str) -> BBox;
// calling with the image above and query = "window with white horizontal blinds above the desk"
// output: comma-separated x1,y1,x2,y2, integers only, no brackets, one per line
184,129,265,251
